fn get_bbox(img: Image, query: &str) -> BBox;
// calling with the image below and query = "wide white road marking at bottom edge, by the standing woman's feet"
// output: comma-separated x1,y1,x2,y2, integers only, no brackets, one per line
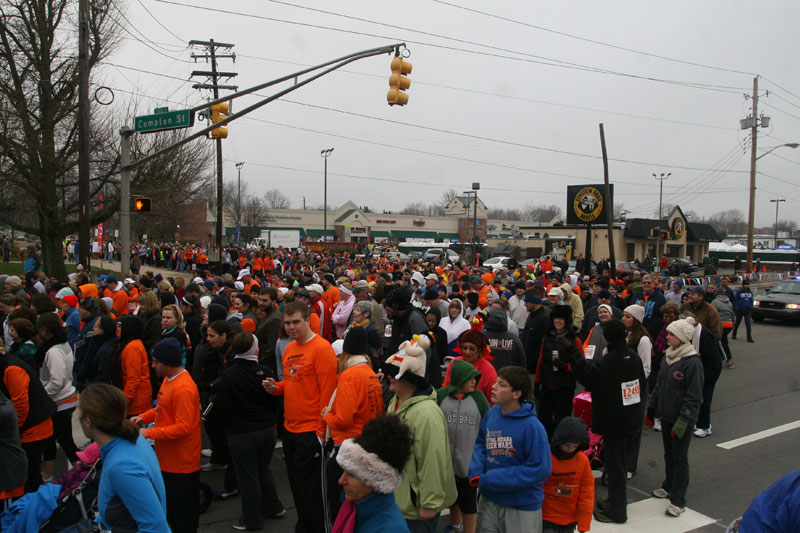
592,498,715,533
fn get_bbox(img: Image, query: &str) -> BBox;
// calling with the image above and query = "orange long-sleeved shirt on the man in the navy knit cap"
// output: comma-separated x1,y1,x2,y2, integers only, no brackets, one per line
139,370,203,474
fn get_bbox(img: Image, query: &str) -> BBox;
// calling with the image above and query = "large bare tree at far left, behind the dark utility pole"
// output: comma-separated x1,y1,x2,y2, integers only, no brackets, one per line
0,0,208,279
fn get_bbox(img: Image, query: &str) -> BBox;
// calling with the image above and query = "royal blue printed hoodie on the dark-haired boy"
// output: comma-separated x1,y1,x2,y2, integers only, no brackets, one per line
469,401,550,511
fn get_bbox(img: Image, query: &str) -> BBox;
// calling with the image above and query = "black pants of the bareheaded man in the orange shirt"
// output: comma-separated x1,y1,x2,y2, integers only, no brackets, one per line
283,430,331,533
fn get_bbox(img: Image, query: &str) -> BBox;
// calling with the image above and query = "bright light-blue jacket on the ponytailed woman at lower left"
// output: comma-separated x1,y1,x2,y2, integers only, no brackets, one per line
97,435,170,533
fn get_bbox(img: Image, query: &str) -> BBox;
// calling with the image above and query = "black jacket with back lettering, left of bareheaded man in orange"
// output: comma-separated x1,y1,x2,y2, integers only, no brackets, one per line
216,359,278,435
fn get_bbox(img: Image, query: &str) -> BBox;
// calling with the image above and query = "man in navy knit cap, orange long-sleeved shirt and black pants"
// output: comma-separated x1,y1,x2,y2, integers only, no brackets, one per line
131,338,202,533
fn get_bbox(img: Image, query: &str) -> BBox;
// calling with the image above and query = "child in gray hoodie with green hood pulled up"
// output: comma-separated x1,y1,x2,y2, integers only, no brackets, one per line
436,359,489,533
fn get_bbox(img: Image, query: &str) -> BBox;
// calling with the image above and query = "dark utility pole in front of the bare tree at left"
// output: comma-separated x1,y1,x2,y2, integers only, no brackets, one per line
77,0,92,270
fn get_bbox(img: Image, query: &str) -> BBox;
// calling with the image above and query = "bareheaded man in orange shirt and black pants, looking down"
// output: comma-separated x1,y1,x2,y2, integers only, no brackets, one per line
264,302,336,533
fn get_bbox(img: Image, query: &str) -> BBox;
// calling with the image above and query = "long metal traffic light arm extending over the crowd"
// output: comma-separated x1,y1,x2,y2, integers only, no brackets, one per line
125,43,405,170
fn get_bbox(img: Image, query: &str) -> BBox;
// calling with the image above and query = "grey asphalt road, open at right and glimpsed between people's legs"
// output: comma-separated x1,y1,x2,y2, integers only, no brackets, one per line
69,314,800,533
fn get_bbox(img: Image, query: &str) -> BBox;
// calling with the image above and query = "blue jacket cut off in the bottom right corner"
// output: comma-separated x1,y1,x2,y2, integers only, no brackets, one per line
739,470,800,533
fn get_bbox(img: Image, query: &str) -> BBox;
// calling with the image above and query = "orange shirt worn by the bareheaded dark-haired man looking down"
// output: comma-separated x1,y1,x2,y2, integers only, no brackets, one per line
276,335,338,436
